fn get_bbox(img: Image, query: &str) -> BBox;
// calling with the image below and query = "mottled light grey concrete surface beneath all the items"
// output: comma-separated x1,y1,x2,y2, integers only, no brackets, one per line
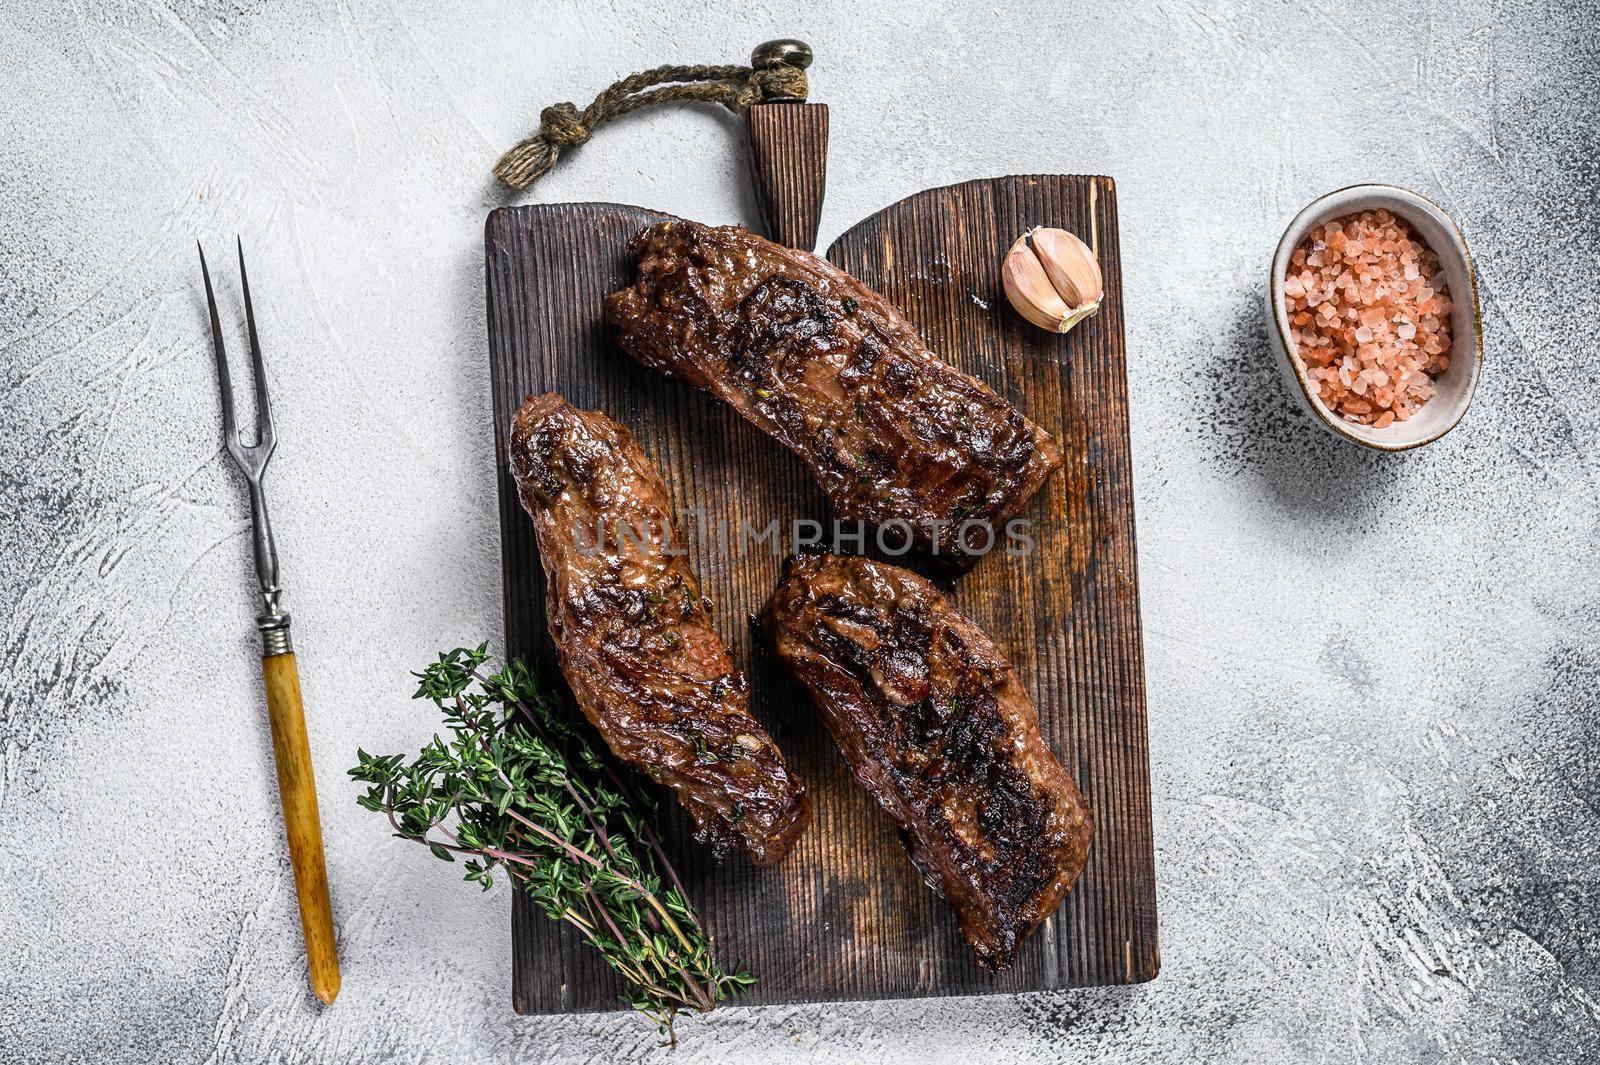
0,0,1600,1065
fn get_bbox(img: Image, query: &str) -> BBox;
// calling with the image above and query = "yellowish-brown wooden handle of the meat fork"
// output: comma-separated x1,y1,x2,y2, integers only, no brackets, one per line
261,651,339,1003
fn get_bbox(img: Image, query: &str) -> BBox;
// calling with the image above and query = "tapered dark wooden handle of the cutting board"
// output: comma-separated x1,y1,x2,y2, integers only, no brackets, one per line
746,102,827,251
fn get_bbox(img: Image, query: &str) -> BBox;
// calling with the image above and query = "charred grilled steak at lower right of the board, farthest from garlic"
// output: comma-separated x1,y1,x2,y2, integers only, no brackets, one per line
762,555,1093,971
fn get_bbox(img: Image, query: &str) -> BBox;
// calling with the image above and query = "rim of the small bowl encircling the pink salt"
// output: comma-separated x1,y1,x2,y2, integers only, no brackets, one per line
1267,182,1483,453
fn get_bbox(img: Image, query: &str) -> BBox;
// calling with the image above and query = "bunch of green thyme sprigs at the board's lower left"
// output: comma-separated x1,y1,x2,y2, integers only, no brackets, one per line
350,644,755,1041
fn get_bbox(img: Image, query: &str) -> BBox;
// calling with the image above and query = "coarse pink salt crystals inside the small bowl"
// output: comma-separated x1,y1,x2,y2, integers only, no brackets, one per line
1283,209,1451,429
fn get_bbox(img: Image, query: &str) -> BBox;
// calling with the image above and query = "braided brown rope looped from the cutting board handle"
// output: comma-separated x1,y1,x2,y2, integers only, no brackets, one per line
494,66,810,190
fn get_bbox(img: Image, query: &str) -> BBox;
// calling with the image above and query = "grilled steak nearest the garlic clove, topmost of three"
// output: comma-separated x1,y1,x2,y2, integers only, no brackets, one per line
606,221,1061,574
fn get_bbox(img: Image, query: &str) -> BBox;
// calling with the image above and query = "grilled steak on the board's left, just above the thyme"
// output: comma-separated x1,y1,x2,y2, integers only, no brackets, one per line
510,392,811,865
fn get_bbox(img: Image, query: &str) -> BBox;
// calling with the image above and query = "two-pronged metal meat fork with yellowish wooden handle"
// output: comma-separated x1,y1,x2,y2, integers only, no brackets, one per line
197,241,339,1003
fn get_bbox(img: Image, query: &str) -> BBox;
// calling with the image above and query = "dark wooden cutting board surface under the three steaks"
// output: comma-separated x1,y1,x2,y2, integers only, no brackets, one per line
486,176,1158,1014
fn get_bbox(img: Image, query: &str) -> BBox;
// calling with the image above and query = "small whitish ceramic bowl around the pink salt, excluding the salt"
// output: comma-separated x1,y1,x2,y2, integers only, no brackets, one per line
1267,185,1483,451
